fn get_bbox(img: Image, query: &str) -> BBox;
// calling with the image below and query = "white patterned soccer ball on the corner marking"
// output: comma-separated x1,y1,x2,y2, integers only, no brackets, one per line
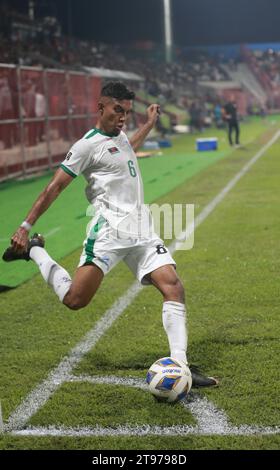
146,357,192,403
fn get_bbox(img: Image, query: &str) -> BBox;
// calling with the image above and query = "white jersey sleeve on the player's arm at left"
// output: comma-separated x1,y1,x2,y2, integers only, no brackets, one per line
60,139,91,178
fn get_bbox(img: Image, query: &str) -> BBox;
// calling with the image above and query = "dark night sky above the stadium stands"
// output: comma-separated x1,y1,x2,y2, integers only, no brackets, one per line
0,0,280,45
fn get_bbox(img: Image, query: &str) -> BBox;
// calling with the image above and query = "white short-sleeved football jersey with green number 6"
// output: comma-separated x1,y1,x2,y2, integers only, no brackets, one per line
60,129,148,232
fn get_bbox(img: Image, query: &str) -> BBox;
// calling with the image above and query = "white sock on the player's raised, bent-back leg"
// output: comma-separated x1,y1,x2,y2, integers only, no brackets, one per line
29,246,72,302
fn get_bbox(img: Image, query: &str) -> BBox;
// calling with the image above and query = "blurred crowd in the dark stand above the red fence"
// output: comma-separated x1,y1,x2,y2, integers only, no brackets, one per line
0,4,232,107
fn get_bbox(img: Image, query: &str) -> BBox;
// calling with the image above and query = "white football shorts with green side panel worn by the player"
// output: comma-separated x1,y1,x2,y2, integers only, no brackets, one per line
78,215,176,285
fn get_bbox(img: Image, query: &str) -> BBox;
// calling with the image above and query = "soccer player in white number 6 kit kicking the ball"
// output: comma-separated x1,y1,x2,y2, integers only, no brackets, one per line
3,82,217,386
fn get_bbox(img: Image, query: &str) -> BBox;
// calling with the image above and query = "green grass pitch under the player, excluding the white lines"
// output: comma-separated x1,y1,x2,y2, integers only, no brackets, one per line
0,119,280,450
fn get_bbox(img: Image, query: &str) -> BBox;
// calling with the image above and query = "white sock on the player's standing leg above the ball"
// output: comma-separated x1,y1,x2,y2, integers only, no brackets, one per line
162,301,187,363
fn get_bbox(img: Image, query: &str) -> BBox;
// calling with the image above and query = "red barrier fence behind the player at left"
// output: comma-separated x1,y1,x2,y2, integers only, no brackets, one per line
0,64,101,181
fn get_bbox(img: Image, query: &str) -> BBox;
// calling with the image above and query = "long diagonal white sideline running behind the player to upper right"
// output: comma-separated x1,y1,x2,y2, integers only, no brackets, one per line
4,130,280,432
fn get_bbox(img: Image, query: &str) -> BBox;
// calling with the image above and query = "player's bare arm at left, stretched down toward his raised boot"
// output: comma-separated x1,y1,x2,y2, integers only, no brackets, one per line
11,168,73,251
